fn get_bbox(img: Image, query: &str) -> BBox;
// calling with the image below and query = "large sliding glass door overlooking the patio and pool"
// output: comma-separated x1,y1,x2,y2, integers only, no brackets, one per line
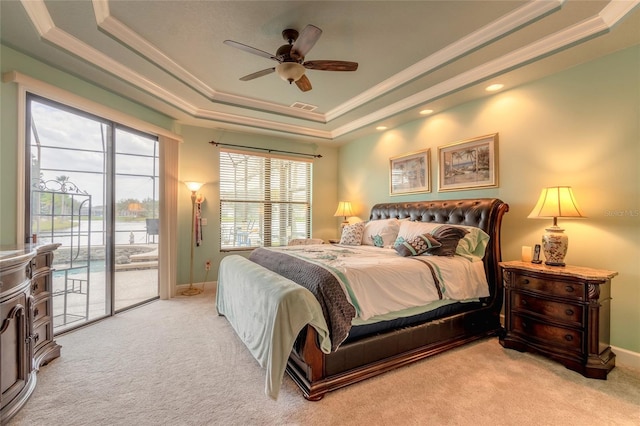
25,95,159,333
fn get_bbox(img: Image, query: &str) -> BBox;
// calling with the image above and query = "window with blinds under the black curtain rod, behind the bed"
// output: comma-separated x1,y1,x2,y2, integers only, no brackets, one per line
220,149,312,250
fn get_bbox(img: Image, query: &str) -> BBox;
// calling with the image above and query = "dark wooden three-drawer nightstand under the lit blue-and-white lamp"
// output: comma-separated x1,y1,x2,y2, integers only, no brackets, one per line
500,261,618,379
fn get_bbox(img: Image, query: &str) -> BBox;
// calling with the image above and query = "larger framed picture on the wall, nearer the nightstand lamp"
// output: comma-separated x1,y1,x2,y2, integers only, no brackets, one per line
438,133,498,192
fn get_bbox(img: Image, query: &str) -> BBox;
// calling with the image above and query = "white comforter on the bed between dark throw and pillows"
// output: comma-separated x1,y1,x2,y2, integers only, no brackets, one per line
274,244,489,320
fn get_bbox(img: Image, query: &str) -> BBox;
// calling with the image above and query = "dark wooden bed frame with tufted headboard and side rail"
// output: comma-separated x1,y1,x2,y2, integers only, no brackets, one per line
286,198,509,401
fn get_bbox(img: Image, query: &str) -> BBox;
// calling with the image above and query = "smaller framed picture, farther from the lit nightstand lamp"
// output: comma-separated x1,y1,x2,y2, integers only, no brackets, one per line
389,149,431,195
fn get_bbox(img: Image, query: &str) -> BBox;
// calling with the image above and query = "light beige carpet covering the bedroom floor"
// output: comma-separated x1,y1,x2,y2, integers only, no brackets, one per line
9,293,640,426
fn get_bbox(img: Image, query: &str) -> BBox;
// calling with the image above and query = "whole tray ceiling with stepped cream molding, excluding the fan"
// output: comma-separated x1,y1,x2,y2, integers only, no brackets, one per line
0,0,640,144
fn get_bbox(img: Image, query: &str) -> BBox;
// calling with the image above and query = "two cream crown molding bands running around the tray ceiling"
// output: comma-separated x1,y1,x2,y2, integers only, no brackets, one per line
21,0,640,140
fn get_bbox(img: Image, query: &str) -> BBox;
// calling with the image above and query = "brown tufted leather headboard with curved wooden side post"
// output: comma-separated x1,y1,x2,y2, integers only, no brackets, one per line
369,198,509,308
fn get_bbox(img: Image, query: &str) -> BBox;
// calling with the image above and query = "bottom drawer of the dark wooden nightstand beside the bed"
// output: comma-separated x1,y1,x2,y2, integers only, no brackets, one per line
513,314,583,353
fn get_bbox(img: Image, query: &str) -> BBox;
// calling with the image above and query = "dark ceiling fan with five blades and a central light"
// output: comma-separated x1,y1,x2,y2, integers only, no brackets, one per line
224,25,358,92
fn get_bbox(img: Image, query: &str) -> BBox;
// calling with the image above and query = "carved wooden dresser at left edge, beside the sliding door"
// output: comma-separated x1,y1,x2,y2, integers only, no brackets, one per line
0,244,60,424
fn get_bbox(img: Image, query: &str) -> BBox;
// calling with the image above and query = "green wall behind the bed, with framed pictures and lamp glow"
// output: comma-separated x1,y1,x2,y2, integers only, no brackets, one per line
338,46,640,352
